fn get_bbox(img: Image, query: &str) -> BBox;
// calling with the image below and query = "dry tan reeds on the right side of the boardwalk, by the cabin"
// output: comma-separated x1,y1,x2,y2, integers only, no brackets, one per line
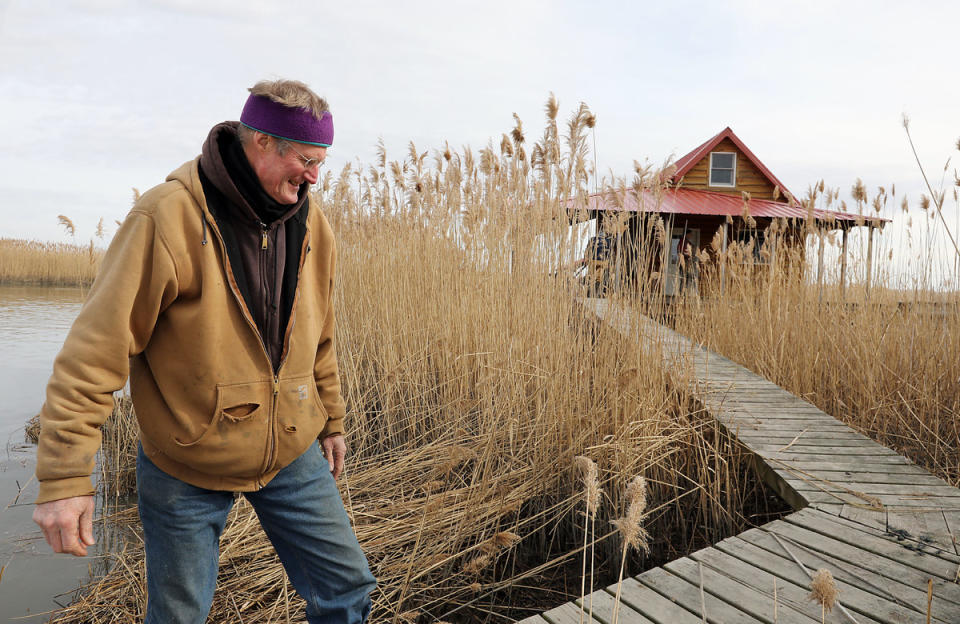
673,185,960,485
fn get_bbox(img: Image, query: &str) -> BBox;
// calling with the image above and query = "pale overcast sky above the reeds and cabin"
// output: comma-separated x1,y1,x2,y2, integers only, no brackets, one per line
0,0,960,276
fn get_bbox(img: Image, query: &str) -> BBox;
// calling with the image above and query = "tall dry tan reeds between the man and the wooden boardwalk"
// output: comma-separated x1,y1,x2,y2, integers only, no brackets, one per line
43,98,780,623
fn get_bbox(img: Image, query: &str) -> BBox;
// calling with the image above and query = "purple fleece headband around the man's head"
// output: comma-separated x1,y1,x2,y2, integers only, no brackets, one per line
240,94,333,147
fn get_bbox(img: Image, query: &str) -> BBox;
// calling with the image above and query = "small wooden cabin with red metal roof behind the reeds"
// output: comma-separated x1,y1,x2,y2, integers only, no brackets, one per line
571,127,889,296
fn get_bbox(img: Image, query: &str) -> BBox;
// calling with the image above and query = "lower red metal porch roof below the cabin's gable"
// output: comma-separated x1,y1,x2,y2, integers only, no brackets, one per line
572,188,890,227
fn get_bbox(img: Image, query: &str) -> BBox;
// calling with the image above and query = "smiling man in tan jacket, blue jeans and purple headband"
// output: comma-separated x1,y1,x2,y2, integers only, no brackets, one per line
34,80,375,624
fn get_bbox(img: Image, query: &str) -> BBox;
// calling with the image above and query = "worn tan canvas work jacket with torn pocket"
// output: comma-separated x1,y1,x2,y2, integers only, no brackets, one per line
37,160,344,503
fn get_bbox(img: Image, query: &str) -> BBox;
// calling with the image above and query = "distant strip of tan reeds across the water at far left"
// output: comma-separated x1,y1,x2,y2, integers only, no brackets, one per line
0,238,103,286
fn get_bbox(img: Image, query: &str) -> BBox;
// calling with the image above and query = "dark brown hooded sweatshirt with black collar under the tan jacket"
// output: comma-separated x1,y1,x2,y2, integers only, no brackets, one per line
199,121,309,371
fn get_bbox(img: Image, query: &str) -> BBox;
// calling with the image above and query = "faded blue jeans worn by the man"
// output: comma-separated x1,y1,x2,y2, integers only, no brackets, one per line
137,444,376,624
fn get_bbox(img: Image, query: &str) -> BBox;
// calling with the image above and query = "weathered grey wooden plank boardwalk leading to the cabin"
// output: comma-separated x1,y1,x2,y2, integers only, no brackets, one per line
523,299,960,624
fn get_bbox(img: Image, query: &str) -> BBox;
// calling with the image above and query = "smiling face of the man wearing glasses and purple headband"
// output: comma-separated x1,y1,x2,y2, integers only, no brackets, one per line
250,134,327,204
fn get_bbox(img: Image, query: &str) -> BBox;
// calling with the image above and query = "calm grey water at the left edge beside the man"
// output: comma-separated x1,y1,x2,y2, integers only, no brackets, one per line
0,286,96,624
